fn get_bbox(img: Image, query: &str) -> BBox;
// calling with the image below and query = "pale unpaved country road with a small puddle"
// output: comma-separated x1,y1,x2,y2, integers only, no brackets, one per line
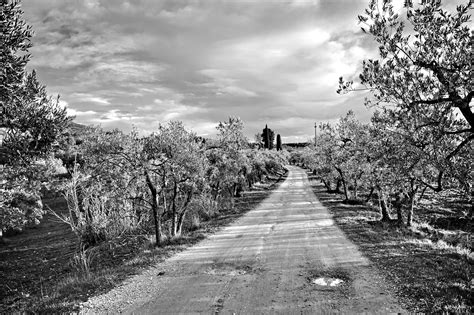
82,166,404,314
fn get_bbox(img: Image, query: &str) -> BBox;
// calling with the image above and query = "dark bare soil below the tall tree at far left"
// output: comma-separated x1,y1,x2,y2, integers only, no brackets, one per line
0,196,77,312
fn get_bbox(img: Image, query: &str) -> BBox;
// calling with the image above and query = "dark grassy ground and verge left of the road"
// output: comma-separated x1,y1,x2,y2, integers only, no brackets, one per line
0,176,282,313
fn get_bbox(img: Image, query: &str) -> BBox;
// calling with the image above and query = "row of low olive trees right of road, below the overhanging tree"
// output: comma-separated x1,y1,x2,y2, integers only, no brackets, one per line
292,112,473,225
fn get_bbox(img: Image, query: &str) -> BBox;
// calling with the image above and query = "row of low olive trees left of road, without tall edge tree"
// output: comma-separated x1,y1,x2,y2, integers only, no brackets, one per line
55,117,285,245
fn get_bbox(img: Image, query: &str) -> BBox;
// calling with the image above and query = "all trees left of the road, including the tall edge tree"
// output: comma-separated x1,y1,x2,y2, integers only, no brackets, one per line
0,0,283,243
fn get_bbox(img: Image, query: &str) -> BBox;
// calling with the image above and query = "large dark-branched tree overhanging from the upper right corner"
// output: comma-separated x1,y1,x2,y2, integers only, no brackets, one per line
338,0,474,198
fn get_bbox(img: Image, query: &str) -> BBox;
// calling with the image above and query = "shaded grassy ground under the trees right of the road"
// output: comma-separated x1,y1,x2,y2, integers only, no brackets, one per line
311,174,474,313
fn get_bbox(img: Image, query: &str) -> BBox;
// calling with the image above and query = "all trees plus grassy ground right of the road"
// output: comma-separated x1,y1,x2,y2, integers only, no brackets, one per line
290,1,474,313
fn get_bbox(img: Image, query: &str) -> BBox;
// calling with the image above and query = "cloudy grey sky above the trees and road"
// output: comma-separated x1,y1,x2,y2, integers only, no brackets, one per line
22,0,462,142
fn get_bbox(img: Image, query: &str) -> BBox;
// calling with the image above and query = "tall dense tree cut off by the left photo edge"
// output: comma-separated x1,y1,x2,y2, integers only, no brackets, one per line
0,0,70,235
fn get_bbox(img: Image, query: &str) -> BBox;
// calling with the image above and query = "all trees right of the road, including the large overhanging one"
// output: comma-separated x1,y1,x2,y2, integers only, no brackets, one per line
302,0,474,225
